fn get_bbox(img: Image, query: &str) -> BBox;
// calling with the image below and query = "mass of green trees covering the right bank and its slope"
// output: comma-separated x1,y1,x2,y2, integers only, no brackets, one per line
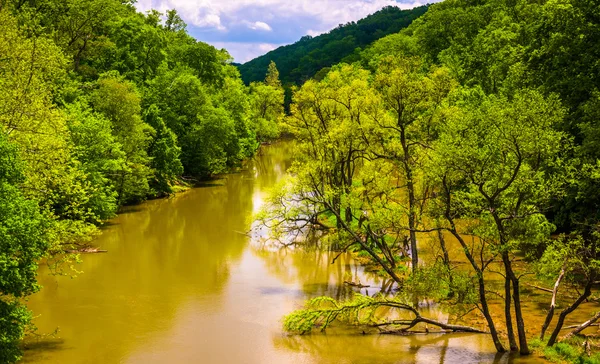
261,0,600,355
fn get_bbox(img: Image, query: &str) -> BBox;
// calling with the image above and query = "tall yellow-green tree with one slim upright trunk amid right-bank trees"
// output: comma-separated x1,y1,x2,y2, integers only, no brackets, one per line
371,57,455,271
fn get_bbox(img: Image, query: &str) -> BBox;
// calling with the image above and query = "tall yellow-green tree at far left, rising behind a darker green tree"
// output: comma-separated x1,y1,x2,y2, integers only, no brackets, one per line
0,10,97,252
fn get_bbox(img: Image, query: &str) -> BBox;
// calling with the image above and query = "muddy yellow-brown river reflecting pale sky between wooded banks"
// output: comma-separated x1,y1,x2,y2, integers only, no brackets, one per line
23,142,536,364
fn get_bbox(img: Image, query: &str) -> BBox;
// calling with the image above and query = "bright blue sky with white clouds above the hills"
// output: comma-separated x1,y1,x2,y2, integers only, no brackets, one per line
136,0,431,63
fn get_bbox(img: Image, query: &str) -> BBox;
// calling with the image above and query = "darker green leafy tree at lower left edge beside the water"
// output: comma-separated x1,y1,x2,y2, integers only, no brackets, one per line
0,133,51,363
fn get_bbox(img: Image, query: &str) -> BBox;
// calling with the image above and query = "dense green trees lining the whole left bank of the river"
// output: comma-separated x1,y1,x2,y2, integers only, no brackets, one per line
0,0,283,363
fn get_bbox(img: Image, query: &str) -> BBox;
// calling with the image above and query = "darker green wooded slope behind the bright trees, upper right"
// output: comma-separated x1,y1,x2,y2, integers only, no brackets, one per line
362,0,600,231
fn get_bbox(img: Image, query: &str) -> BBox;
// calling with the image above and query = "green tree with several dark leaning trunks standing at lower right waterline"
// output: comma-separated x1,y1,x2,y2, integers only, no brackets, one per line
429,90,564,354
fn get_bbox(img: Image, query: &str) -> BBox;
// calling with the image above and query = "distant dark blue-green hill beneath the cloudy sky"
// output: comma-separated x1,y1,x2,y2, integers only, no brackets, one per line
239,6,428,84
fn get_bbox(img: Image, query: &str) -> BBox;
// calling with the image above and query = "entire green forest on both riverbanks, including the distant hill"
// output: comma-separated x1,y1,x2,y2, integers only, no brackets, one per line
0,0,600,363
